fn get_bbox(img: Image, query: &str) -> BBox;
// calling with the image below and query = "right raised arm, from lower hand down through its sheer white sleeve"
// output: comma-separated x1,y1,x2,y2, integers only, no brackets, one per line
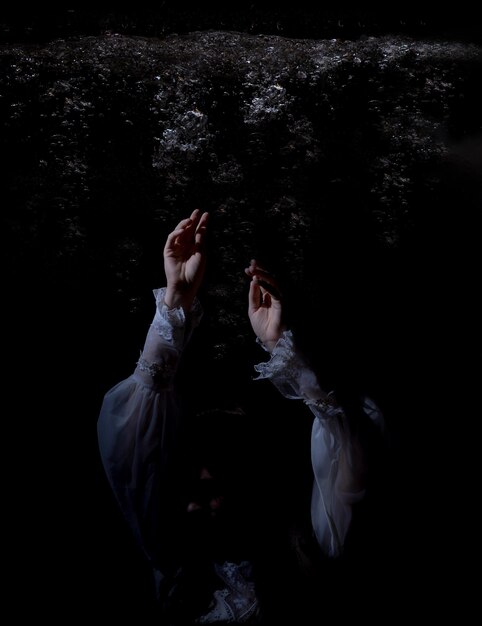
245,261,364,556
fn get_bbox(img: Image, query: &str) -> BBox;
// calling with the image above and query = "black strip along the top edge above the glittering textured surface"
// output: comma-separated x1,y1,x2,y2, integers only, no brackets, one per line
0,0,481,42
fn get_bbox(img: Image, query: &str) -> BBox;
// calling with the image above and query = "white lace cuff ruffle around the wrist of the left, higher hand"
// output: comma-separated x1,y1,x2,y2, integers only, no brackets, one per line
152,287,203,351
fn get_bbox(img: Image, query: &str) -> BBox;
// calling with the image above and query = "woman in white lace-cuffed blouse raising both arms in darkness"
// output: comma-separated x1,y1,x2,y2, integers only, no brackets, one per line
98,210,380,623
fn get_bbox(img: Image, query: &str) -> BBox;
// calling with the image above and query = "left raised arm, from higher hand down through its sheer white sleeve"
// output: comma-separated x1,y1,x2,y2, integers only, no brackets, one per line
97,211,207,562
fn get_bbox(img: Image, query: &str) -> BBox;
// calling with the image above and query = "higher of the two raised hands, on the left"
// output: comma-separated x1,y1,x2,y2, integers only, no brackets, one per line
164,209,208,311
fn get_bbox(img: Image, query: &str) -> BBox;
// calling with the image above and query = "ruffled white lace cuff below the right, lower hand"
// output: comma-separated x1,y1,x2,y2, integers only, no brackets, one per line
254,330,343,419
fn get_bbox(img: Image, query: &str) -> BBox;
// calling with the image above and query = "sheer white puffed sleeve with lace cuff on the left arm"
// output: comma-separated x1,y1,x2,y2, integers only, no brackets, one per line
97,289,202,559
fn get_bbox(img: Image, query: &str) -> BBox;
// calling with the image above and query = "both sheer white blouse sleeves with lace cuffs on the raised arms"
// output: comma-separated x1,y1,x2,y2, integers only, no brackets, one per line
98,289,380,559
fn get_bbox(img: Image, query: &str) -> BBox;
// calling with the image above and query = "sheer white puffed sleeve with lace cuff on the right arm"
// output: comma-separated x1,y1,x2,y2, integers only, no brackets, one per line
255,331,376,556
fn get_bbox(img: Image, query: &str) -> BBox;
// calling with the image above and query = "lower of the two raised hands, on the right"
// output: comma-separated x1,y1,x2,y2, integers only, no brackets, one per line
244,259,285,352
